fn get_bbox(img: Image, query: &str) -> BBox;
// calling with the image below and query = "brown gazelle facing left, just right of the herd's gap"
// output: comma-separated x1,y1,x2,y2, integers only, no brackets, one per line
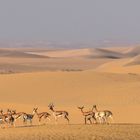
78,106,96,124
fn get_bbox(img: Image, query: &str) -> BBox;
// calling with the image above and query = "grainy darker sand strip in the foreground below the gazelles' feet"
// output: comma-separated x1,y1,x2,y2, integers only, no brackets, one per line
0,124,140,140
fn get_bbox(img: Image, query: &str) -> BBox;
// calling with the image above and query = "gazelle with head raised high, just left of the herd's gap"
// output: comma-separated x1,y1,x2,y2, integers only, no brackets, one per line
48,103,69,123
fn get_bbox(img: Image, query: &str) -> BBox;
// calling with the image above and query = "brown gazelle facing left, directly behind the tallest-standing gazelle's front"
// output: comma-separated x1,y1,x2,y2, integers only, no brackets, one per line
35,108,51,123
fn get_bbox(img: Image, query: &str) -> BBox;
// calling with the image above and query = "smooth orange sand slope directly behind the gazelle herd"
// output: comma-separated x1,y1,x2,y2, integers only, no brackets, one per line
0,71,140,123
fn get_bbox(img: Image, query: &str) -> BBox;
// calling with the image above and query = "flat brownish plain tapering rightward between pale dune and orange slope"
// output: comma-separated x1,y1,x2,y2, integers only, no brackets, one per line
0,57,110,73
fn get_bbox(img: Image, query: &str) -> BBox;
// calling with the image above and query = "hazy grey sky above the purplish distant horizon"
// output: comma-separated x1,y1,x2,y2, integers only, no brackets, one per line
0,0,140,42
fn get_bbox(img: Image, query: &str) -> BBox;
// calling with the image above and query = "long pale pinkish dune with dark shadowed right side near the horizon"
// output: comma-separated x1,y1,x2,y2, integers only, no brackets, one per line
28,48,123,58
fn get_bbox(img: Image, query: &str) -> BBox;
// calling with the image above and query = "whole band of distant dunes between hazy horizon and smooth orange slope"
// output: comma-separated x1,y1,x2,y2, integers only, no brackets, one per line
0,46,140,73
